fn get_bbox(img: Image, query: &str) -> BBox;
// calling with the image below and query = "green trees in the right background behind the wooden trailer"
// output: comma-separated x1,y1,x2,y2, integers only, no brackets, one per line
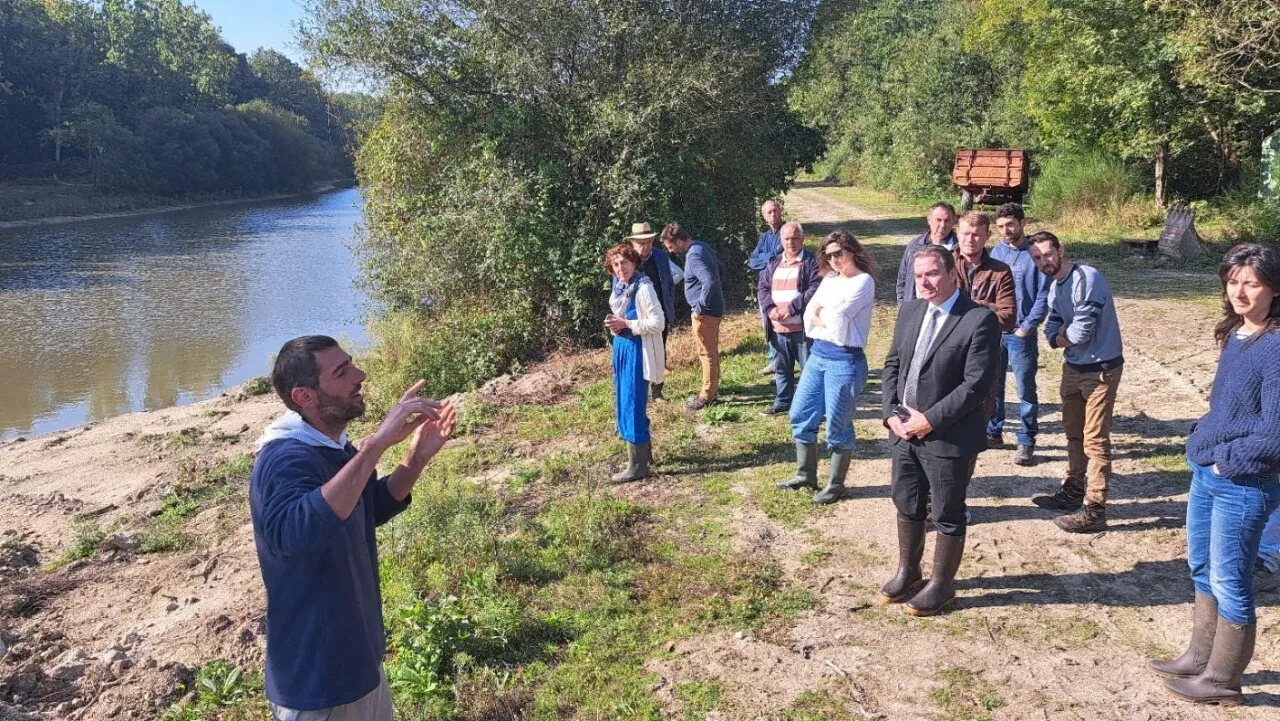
790,0,1280,205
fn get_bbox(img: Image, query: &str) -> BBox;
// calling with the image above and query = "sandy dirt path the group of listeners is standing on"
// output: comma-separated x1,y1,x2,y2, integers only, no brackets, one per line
652,188,1280,720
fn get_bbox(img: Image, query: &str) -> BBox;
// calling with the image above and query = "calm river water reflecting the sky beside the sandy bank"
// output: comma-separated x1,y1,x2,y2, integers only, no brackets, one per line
0,190,365,438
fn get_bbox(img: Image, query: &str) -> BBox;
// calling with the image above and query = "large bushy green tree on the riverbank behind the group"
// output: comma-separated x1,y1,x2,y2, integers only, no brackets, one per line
306,0,819,394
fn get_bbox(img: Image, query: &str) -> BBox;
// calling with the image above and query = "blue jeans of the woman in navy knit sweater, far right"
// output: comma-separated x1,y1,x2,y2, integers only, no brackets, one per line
1187,458,1280,625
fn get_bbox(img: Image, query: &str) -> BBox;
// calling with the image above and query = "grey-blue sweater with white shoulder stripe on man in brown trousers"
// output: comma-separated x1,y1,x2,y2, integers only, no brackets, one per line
1044,263,1124,373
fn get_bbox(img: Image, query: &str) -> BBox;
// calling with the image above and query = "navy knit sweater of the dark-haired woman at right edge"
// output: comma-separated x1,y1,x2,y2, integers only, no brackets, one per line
1187,333,1280,479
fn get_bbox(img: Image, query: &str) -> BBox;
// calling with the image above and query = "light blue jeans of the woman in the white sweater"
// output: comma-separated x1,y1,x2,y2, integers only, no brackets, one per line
791,353,867,451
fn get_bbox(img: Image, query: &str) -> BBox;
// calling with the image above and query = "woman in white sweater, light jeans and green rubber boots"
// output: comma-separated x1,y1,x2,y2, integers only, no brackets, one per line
778,229,876,503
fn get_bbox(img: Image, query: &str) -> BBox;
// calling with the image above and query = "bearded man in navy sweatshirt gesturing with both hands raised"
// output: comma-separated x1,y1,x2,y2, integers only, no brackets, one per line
250,336,457,721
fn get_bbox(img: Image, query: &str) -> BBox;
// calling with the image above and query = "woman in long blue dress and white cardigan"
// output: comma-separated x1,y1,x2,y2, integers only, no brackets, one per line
604,243,667,483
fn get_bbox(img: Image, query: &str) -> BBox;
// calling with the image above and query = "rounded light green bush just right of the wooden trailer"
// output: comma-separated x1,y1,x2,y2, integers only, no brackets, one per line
1030,151,1142,218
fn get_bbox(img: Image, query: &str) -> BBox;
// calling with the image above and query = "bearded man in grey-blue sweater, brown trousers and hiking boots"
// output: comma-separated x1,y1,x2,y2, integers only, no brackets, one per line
1028,232,1124,533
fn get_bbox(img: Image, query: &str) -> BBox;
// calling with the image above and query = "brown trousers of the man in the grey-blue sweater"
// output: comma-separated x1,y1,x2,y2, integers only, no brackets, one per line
1061,365,1123,506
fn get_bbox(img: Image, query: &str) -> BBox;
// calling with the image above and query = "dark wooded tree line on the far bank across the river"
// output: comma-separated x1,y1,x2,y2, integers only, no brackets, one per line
0,0,375,196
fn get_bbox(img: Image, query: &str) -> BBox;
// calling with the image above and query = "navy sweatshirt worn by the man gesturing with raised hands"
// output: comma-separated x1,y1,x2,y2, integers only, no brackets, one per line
248,438,410,711
